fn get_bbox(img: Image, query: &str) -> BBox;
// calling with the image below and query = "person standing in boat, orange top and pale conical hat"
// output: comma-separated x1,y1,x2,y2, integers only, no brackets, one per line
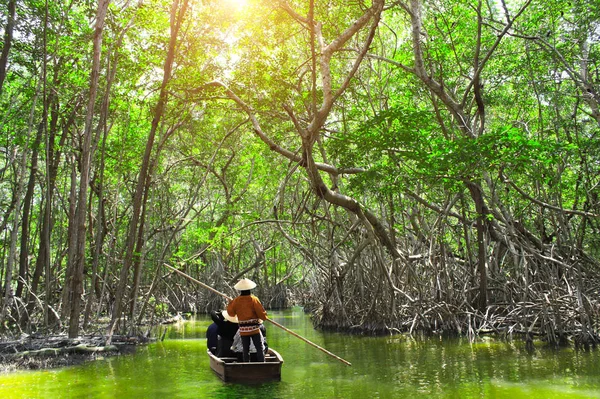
227,278,267,362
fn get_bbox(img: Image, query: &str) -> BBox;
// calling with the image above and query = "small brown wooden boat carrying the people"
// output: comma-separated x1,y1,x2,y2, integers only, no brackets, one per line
207,348,283,383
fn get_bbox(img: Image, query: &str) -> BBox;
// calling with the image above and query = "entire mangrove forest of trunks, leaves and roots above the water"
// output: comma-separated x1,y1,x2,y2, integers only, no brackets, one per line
0,0,600,344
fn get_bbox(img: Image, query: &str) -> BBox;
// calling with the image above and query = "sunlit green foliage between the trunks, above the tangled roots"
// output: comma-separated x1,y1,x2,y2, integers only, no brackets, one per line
0,0,600,330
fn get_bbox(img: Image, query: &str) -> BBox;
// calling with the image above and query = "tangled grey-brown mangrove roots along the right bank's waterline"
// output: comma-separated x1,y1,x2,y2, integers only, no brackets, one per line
306,241,600,349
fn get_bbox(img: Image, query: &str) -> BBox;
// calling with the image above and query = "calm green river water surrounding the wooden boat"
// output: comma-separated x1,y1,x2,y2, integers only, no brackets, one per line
0,309,600,399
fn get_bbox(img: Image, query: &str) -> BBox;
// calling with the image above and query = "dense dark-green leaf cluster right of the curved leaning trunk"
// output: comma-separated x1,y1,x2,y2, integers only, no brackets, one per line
329,101,577,193
